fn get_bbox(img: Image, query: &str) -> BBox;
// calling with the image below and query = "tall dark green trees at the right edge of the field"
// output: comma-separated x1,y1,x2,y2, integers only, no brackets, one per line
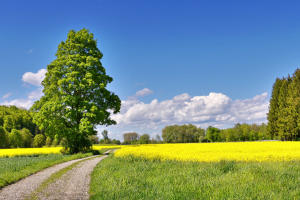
268,69,300,140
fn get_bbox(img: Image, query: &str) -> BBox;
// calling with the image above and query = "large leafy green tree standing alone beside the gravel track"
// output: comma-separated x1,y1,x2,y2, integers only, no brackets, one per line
32,29,121,153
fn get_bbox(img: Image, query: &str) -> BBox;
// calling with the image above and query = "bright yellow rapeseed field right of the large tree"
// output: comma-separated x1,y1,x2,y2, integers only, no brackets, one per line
115,141,300,162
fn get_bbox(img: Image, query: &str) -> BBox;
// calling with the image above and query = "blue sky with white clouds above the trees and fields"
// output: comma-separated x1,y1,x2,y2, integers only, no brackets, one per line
0,0,300,138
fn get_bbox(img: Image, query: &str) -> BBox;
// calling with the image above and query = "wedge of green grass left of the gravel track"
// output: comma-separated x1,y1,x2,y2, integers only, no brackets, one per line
0,153,92,189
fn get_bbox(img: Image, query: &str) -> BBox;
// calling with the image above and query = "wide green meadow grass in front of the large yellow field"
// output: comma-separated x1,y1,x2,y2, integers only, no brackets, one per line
90,156,300,200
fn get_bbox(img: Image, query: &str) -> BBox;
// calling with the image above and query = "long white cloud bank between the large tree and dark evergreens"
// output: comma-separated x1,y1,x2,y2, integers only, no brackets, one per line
101,92,269,139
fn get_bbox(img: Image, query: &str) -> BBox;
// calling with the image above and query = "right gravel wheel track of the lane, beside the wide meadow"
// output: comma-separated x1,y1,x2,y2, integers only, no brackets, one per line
37,156,107,200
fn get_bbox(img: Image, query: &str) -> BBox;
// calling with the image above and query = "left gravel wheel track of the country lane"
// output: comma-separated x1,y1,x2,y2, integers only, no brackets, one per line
0,157,94,200
